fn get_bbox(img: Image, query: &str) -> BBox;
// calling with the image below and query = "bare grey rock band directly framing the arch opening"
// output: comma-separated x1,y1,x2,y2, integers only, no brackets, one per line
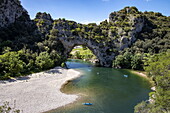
59,37,115,67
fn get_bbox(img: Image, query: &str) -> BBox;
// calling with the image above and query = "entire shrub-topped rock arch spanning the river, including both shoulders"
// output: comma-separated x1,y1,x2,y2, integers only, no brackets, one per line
35,8,146,67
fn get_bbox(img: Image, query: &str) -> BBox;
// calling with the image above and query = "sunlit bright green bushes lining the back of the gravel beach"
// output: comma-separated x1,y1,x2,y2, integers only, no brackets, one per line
0,49,61,79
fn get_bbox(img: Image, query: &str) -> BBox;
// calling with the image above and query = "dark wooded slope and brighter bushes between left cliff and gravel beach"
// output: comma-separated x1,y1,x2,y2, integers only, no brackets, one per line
0,14,65,79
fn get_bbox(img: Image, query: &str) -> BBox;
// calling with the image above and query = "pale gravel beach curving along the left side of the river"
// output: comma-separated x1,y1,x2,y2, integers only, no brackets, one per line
0,67,80,113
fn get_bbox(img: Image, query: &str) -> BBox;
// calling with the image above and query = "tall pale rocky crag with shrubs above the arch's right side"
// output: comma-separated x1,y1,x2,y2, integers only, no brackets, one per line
109,7,145,50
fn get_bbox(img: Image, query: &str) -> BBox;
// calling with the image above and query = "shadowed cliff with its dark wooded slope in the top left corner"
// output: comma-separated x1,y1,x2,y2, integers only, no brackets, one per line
0,0,42,54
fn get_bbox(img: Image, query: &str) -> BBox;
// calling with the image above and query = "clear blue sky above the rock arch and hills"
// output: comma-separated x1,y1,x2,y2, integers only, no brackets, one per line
20,0,170,24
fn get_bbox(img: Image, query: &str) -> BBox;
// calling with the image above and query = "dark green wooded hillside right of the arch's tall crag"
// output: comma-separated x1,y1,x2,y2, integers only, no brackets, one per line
113,7,170,70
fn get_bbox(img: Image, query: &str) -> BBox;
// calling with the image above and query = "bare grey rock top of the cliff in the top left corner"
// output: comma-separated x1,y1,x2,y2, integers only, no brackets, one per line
0,0,30,28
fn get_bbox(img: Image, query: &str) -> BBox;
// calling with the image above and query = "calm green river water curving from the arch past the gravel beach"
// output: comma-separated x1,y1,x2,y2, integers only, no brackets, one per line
48,60,151,113
